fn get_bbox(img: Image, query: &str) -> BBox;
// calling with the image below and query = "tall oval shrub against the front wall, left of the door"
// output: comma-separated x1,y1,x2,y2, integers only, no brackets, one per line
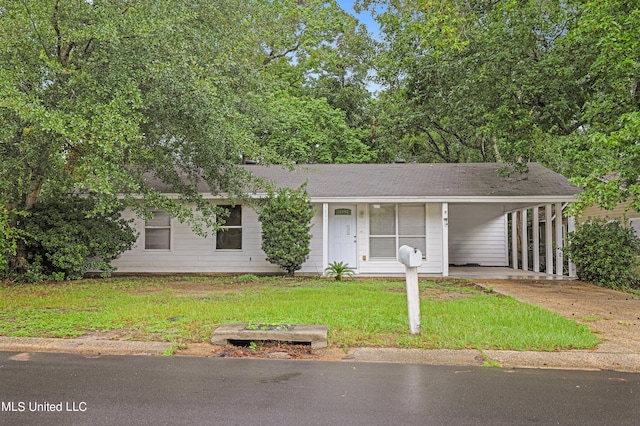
258,184,314,275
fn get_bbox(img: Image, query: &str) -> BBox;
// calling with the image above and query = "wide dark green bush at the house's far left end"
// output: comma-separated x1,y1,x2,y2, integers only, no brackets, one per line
22,196,136,281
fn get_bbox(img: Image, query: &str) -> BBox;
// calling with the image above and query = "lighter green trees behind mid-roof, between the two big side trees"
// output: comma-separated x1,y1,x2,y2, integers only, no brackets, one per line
255,0,380,163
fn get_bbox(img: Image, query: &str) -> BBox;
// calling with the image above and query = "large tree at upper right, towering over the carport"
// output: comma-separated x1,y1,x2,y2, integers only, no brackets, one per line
359,0,640,211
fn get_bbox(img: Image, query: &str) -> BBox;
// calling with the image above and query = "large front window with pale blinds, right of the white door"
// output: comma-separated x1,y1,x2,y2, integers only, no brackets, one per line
369,204,427,259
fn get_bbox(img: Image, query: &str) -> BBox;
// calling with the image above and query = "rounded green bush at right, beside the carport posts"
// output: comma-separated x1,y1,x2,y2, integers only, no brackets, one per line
565,218,640,289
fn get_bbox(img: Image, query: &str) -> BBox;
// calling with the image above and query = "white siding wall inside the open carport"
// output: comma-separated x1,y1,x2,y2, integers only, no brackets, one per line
449,203,509,266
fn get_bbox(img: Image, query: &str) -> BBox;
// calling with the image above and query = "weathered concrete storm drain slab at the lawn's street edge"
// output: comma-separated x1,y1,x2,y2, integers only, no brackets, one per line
211,323,328,349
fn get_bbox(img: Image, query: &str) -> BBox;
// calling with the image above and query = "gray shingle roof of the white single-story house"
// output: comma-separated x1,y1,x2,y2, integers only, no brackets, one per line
245,163,580,198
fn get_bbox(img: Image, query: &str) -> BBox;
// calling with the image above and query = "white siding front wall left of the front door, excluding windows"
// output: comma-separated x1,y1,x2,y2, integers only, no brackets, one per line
113,206,322,273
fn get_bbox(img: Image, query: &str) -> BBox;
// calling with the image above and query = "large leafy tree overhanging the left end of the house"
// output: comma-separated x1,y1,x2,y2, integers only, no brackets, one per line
0,0,282,268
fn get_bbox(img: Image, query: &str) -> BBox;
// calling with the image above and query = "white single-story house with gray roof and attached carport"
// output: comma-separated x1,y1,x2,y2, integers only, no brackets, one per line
113,163,579,276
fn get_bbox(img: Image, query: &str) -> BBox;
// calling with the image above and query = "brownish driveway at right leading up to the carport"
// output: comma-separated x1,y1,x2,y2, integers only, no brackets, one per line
474,279,640,354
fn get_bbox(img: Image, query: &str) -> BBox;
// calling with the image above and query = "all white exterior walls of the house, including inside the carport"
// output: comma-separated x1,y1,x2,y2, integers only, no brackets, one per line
113,203,509,275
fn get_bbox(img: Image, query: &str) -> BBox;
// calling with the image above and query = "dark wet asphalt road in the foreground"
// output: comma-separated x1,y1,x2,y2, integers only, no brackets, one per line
0,352,640,425
